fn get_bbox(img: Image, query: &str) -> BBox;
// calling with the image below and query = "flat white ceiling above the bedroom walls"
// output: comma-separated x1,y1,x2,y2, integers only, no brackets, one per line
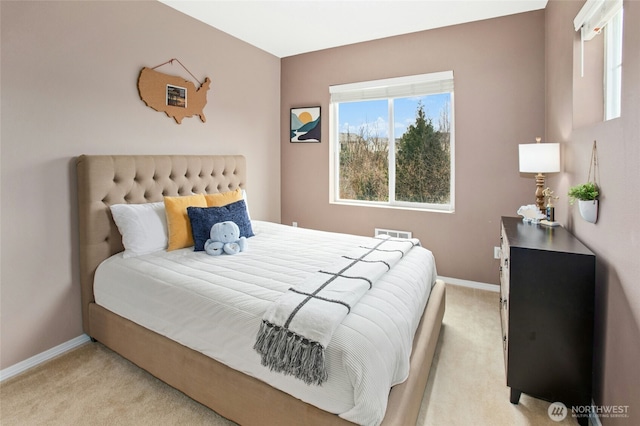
159,0,547,58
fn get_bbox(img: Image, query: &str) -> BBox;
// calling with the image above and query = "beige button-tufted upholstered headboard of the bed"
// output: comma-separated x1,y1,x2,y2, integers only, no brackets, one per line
76,155,247,333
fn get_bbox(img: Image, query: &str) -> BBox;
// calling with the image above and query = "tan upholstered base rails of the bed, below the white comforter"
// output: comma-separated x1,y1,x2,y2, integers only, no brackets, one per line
89,280,445,426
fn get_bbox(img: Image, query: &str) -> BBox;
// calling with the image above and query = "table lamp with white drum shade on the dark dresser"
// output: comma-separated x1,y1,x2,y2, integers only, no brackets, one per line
518,138,560,213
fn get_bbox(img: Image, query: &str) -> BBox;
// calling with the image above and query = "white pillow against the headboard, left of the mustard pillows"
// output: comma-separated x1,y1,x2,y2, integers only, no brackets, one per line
111,201,169,257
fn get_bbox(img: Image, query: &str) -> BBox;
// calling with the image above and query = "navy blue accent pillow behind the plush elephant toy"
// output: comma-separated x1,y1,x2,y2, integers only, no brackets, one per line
187,200,254,251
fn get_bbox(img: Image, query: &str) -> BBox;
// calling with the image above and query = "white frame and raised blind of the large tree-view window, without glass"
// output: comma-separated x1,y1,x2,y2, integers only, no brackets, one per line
329,71,455,213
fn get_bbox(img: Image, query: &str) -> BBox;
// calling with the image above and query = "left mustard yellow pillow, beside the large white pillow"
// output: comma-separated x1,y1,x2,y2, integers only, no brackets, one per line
164,194,207,251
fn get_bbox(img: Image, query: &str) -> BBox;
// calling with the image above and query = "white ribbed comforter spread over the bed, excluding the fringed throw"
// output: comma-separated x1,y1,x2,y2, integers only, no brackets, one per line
94,221,436,425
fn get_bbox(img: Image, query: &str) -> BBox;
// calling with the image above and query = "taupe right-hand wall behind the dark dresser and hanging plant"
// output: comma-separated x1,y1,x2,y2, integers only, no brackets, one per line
545,0,640,426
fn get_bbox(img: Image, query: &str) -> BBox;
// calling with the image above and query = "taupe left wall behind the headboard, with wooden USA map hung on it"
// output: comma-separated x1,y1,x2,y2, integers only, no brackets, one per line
0,1,280,368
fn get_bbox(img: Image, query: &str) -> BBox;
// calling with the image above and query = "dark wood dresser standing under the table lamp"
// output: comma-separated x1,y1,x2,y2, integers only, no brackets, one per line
500,217,596,424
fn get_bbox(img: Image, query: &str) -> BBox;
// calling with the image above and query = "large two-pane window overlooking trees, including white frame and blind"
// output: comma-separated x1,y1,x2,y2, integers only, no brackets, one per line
330,71,454,212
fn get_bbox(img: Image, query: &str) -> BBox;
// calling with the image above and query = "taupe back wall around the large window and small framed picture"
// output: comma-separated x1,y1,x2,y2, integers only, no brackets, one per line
280,11,544,284
